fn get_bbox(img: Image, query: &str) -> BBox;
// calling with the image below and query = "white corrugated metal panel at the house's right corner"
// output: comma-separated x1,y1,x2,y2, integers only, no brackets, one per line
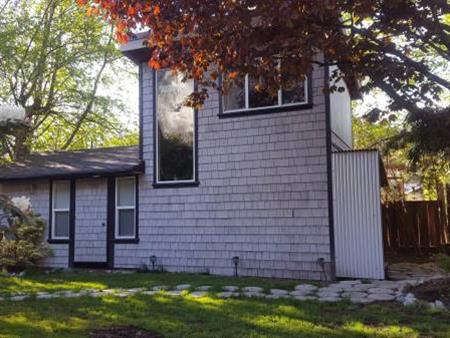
333,151,384,279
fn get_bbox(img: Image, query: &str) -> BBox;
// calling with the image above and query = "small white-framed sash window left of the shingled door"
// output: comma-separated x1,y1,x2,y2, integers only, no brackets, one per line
51,181,70,239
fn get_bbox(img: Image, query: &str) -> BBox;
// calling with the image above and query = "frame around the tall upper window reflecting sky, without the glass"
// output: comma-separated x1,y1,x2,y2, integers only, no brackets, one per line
154,70,197,185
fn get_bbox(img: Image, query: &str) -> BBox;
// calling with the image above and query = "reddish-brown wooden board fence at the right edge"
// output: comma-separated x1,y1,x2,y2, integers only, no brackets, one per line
382,201,450,250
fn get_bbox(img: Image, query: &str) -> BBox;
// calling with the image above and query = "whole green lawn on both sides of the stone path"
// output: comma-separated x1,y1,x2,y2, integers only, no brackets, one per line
0,272,450,338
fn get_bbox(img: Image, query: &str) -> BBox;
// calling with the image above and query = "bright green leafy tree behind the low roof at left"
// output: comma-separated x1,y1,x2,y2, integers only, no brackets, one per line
0,0,137,160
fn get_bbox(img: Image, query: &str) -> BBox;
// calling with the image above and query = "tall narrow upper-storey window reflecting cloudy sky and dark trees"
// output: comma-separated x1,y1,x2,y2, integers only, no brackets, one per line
155,71,195,183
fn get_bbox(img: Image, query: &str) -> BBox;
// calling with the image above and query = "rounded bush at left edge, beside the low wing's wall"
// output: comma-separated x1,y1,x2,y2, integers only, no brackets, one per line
0,196,51,272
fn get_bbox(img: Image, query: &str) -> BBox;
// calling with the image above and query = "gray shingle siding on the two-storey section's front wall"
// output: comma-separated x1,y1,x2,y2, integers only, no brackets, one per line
115,66,330,279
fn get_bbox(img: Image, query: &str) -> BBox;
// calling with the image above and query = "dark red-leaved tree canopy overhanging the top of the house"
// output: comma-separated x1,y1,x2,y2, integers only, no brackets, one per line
78,0,450,161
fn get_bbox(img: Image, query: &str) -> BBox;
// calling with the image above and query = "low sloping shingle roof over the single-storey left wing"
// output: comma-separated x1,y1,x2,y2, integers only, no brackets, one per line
0,146,144,181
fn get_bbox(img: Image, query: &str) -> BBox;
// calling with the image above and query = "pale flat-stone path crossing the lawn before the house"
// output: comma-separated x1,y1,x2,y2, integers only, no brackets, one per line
0,279,445,309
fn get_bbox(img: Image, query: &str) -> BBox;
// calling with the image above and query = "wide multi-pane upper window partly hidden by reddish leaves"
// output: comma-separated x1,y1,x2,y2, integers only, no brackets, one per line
223,75,308,113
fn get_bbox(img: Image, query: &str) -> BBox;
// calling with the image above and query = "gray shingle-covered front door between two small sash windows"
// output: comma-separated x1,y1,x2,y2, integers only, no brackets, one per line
74,178,108,268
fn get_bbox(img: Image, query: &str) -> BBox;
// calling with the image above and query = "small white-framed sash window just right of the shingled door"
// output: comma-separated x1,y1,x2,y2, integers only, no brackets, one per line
116,177,136,239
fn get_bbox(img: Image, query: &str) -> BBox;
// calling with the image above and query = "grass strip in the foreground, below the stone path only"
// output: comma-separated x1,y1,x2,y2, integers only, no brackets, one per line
0,295,450,338
